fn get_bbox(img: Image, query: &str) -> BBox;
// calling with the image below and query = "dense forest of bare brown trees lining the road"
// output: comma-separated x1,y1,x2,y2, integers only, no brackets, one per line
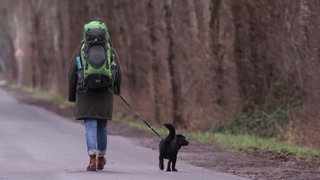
0,0,320,147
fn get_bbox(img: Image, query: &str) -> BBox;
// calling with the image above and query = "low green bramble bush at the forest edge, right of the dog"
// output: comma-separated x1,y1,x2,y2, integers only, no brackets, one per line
213,98,296,138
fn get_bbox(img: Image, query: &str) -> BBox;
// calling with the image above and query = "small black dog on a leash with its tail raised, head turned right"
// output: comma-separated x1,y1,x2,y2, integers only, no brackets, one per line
159,124,189,171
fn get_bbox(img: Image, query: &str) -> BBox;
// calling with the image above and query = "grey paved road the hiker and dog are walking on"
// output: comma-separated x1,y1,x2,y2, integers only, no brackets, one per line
0,88,248,180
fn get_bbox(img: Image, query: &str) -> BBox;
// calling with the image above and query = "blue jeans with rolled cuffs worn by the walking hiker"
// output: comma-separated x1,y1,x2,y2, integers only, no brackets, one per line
84,119,108,155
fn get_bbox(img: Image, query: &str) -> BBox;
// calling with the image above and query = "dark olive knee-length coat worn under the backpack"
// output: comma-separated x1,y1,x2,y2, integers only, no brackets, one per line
68,52,121,120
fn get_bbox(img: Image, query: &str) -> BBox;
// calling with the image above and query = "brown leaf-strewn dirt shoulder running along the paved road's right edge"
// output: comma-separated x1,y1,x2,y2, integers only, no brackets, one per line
1,87,320,180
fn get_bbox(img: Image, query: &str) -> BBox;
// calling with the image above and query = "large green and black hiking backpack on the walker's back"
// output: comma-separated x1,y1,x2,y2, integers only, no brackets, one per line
77,21,114,92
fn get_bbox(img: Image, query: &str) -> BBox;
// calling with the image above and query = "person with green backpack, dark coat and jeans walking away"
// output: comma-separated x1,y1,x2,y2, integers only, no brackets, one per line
68,20,121,171
